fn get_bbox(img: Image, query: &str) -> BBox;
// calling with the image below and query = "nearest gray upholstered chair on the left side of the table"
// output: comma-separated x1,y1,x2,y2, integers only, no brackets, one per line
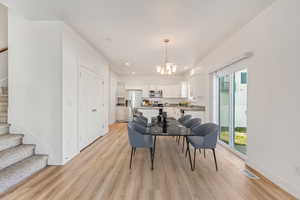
128,122,154,170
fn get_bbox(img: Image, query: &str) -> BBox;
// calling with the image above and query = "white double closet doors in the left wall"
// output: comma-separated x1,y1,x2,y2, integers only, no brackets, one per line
78,67,104,150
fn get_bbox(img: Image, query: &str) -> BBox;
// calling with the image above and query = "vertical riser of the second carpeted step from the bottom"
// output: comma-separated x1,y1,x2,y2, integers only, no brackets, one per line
0,145,34,170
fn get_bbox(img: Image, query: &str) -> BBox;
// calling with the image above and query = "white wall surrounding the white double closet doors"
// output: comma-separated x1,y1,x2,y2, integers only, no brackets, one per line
62,25,110,163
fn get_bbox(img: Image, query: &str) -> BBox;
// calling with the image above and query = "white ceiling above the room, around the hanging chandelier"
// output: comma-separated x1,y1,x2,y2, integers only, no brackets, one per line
0,0,274,74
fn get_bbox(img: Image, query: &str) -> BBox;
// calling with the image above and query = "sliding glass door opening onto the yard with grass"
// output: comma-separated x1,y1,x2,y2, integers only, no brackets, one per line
217,69,248,154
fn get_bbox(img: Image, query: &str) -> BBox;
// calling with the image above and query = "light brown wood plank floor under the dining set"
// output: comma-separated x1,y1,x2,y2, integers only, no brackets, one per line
2,124,295,200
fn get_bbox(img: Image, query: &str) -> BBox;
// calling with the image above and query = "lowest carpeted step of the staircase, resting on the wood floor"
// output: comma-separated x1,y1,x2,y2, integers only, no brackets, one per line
0,155,48,194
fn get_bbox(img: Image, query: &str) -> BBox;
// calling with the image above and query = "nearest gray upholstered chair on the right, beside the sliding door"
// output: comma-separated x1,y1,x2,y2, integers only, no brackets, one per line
187,123,219,171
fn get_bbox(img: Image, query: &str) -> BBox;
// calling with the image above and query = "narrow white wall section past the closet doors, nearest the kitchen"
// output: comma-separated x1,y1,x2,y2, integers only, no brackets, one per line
109,71,118,124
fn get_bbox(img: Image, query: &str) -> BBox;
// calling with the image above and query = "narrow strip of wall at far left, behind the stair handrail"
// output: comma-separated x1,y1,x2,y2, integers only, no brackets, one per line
0,4,8,87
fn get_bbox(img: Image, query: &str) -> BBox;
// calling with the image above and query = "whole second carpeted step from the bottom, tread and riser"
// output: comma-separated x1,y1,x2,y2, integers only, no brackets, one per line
0,144,35,170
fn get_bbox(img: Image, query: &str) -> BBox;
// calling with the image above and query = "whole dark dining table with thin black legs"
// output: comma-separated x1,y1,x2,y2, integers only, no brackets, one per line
143,118,196,170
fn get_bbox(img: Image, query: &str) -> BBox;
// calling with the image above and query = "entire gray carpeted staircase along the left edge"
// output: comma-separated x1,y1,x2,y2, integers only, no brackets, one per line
0,88,48,195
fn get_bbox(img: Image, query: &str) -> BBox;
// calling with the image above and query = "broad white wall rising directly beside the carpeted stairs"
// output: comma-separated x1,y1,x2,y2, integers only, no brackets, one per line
8,11,63,164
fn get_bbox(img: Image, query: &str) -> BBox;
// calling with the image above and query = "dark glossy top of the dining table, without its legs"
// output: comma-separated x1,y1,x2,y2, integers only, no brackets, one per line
145,119,195,136
